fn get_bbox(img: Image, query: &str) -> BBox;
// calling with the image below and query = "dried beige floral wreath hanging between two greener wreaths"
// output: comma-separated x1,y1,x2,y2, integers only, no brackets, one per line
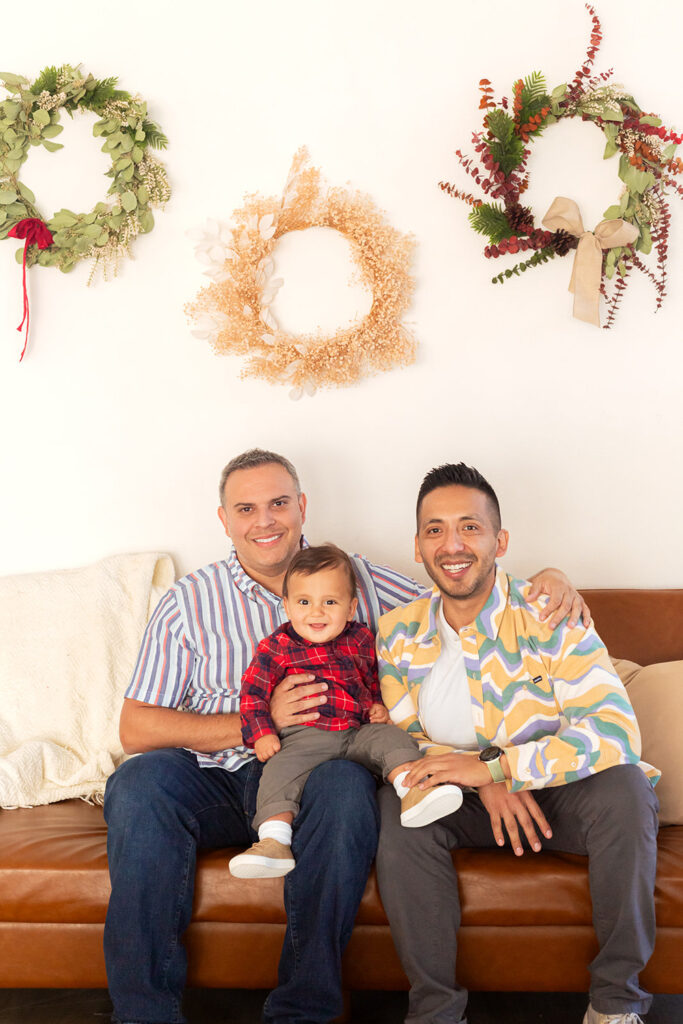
185,147,417,398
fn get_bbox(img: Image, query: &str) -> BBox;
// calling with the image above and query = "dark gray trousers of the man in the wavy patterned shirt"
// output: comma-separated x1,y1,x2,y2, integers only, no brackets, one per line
377,765,658,1024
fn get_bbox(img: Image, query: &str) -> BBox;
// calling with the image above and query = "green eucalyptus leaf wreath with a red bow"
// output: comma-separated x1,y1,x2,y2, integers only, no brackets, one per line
0,65,171,280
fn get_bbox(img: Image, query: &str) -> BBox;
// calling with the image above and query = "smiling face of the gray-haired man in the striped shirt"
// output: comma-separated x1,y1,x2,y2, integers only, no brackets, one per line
218,463,306,593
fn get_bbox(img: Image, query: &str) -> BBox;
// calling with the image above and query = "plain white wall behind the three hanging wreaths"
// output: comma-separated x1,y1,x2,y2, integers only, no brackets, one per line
0,0,683,587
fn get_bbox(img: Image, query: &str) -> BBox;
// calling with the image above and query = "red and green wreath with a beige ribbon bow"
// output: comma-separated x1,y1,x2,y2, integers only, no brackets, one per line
439,4,683,328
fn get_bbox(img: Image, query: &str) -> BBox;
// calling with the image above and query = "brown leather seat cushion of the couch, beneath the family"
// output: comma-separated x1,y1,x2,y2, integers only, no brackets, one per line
0,800,683,927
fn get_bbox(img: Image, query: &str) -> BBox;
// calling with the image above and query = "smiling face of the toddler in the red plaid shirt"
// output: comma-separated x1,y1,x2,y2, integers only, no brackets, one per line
285,568,358,643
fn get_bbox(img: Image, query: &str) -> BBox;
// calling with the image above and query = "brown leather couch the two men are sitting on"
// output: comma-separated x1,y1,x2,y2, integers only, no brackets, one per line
0,590,683,992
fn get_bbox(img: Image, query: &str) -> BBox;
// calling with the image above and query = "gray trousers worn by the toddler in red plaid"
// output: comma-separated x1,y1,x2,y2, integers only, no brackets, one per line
252,723,422,828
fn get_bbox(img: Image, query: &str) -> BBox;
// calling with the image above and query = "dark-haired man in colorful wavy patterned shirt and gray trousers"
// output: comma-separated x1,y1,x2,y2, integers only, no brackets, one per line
378,463,658,1024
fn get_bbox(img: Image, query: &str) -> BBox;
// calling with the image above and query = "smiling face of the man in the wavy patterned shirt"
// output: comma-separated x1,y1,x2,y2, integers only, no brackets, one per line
415,484,508,600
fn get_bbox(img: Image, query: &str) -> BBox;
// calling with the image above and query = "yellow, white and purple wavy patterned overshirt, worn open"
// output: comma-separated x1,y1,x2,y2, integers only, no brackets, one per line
377,567,659,793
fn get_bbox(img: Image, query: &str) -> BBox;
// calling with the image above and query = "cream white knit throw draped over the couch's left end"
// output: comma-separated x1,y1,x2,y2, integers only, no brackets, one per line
0,554,174,808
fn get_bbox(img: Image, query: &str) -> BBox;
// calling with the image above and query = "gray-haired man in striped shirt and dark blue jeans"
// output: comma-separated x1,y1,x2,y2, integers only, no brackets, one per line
104,450,586,1024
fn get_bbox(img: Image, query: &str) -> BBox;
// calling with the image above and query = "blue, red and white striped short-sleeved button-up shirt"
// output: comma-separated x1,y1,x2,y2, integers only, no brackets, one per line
125,548,424,771
